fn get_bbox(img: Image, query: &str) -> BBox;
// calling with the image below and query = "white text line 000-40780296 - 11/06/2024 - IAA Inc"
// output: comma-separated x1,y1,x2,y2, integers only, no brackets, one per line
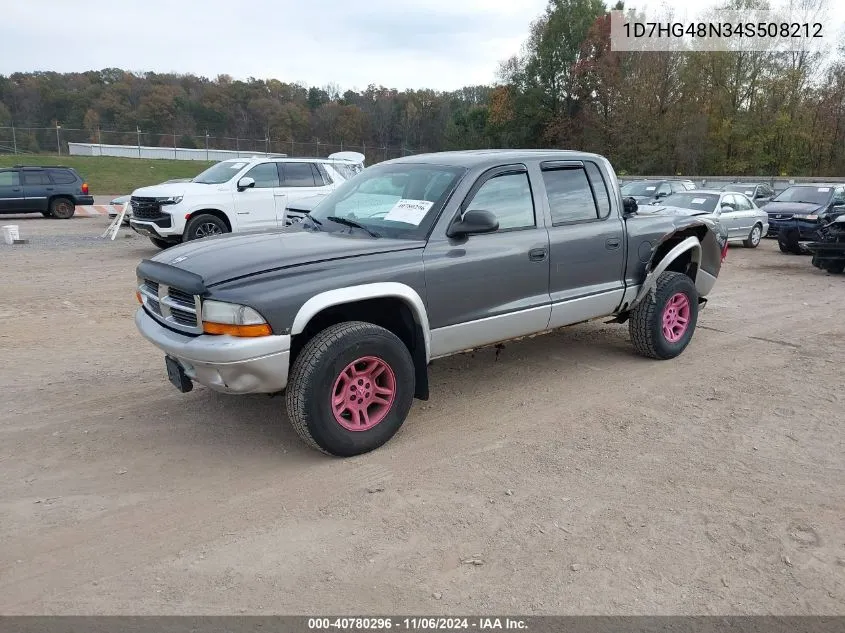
308,617,528,631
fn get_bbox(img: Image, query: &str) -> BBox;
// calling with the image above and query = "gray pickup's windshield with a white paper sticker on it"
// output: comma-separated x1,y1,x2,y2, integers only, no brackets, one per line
309,164,466,239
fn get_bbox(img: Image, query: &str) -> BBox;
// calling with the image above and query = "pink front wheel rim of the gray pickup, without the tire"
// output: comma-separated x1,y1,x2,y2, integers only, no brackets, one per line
332,356,396,431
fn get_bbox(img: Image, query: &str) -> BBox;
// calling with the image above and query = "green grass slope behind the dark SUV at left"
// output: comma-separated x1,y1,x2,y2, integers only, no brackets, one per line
0,154,214,196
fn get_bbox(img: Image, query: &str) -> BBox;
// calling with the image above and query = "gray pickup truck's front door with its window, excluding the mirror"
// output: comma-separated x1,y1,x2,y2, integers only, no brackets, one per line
424,165,551,357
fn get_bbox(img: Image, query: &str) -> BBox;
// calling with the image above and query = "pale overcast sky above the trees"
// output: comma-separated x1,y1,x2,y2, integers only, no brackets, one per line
0,0,845,90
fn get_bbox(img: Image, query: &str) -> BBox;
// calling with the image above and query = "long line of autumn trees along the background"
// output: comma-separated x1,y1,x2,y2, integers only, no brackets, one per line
0,0,845,176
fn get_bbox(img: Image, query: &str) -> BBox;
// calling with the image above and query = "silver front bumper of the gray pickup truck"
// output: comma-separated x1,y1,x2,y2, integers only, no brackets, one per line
135,308,291,394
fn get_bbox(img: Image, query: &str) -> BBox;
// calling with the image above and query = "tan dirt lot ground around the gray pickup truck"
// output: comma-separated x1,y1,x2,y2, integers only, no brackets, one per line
0,218,845,614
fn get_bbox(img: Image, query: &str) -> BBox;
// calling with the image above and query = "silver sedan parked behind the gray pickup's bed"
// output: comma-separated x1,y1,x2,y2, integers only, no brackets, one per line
640,189,769,248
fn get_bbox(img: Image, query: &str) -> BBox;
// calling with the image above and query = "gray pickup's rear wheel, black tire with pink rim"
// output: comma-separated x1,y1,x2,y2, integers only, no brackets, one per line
628,271,698,360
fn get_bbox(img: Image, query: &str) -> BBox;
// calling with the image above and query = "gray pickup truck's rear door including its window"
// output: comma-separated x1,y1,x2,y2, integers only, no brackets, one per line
540,160,625,328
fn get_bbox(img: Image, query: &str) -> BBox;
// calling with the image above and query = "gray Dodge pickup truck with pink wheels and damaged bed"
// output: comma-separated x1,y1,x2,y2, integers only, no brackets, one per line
135,150,727,456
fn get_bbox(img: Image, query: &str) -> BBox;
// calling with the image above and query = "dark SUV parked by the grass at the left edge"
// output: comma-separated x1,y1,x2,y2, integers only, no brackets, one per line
0,165,94,220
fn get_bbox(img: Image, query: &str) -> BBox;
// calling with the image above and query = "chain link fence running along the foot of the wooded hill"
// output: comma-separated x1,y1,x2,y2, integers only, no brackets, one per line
0,126,417,165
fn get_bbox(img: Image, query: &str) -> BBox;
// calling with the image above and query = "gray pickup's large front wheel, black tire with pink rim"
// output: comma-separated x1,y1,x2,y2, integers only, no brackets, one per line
285,321,415,457
